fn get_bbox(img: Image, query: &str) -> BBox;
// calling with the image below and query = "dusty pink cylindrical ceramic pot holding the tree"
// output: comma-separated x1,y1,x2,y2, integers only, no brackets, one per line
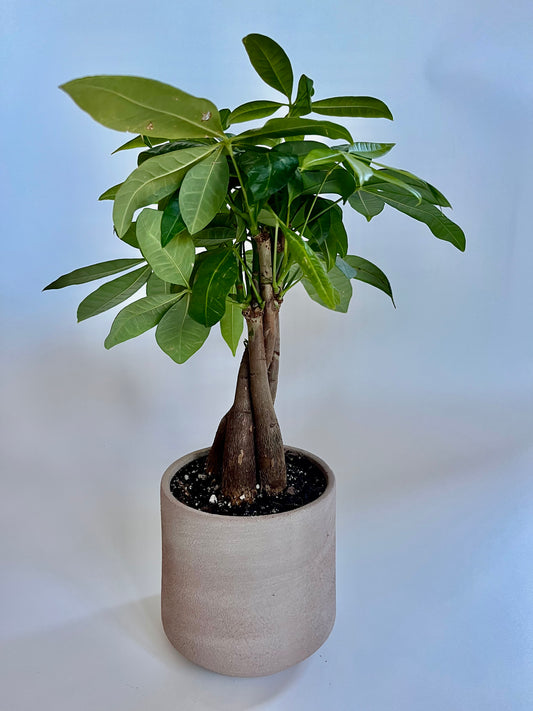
161,447,335,676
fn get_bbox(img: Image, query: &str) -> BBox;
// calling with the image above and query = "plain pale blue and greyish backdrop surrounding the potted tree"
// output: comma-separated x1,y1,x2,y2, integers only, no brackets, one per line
0,0,533,711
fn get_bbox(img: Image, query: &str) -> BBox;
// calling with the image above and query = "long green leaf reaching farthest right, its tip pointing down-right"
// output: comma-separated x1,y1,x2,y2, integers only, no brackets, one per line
365,183,466,252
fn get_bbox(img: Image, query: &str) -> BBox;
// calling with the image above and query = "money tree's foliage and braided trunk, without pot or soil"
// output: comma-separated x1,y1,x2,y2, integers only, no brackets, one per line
46,34,465,504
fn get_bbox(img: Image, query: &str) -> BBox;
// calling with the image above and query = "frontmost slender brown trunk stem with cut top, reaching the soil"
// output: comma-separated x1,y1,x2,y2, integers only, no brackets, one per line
244,309,287,494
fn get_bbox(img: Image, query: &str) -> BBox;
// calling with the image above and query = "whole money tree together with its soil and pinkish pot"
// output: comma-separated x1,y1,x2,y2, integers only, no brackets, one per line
46,34,465,676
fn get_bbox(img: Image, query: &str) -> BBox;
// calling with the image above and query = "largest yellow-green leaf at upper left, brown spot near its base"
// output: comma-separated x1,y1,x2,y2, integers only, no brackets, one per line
59,76,224,138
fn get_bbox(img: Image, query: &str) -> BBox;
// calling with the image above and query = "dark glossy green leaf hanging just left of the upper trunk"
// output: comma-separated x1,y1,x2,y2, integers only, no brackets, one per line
189,247,238,326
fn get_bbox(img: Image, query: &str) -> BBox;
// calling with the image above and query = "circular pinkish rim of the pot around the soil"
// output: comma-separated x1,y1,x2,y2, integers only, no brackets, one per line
161,445,336,521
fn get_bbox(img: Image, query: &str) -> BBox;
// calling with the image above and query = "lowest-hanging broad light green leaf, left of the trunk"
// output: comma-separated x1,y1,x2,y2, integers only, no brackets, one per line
155,293,210,363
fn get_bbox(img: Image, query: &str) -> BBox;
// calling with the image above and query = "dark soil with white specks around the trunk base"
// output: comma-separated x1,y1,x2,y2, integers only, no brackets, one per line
170,452,327,516
